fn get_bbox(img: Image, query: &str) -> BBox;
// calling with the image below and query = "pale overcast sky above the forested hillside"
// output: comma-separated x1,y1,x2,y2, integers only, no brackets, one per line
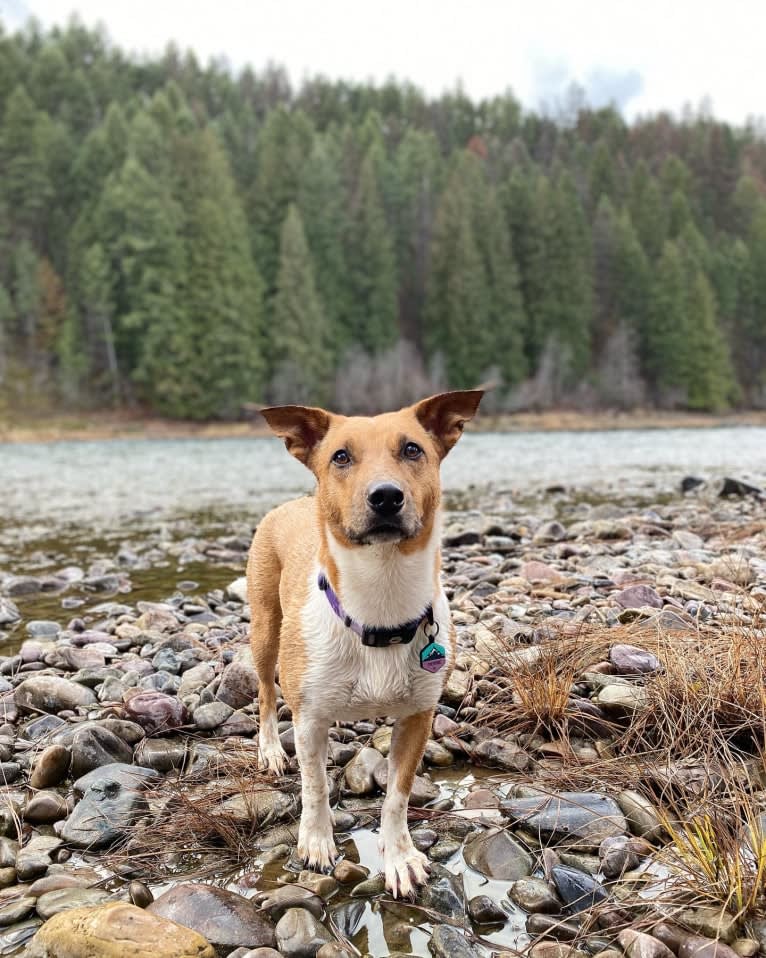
0,0,766,123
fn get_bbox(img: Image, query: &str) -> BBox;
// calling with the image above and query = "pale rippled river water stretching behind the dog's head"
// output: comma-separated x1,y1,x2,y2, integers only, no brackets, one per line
0,427,766,537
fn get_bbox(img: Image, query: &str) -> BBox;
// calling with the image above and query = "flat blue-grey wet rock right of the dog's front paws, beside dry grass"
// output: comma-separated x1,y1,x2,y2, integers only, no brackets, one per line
500,792,628,848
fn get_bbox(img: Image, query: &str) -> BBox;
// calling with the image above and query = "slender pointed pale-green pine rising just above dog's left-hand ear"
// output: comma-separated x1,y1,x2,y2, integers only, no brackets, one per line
272,203,333,405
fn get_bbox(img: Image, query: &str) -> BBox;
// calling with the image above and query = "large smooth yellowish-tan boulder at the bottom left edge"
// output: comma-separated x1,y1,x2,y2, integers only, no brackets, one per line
28,902,215,958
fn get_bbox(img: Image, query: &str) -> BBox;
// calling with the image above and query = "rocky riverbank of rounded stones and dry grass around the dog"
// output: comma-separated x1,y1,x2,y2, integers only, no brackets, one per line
0,481,766,958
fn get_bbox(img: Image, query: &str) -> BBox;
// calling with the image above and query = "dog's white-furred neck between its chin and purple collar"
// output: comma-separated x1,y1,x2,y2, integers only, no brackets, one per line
324,513,441,628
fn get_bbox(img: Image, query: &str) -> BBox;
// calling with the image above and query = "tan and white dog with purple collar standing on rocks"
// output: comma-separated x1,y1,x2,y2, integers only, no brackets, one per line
247,389,483,898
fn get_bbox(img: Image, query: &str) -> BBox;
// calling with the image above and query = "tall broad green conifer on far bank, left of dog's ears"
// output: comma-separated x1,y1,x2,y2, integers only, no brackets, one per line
135,130,264,419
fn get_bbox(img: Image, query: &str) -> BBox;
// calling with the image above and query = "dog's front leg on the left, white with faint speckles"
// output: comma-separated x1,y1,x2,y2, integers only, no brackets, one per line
295,718,337,872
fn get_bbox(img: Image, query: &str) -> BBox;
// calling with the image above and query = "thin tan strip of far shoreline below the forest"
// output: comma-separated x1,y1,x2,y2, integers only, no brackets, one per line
0,409,766,444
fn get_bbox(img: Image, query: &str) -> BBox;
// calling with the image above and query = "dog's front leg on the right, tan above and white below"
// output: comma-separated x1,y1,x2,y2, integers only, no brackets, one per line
380,711,433,898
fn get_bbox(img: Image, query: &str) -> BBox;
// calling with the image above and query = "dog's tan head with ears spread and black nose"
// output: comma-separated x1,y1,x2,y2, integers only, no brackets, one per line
261,389,483,547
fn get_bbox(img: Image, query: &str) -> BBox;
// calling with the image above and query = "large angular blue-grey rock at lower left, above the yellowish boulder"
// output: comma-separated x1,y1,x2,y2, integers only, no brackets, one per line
61,777,148,849
